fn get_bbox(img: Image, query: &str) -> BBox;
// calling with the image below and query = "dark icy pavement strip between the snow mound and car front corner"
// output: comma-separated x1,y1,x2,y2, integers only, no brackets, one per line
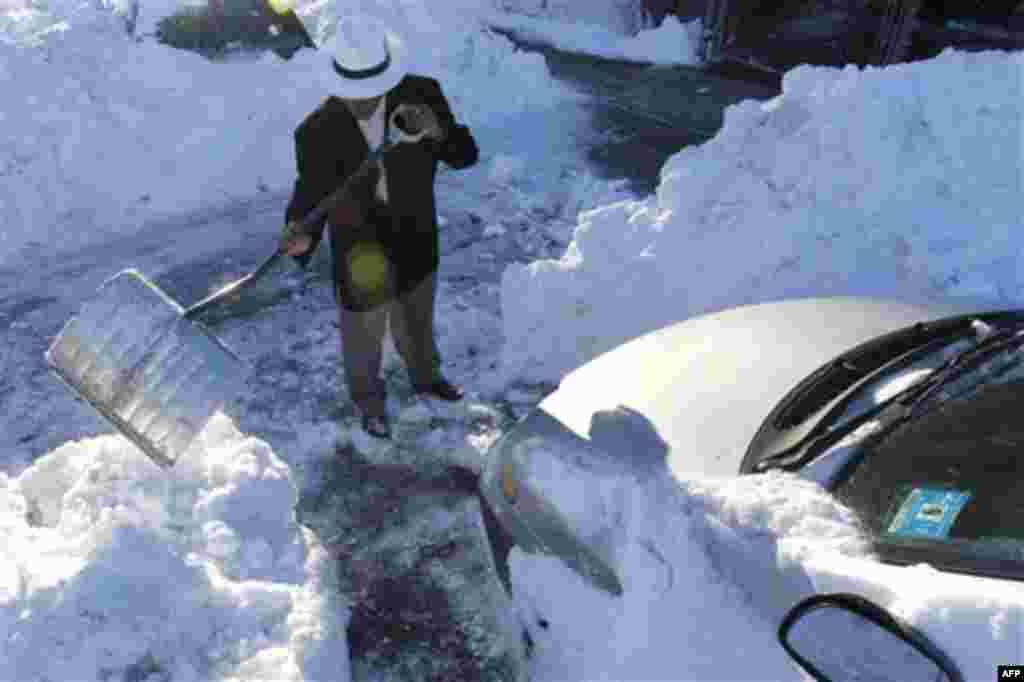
297,438,525,681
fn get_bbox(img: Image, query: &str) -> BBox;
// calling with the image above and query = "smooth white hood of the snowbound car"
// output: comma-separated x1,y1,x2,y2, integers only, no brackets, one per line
540,298,979,476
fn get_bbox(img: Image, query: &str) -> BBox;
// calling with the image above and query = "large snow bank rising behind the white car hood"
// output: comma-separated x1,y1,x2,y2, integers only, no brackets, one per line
502,50,1024,381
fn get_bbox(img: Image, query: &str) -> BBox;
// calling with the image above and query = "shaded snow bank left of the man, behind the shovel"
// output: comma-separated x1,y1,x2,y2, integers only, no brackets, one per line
0,29,309,262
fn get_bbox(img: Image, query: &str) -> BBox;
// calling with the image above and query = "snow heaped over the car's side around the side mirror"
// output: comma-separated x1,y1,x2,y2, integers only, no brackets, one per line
510,462,1024,682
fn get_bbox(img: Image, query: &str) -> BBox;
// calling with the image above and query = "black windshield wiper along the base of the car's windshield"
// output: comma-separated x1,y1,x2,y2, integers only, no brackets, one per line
755,321,1024,471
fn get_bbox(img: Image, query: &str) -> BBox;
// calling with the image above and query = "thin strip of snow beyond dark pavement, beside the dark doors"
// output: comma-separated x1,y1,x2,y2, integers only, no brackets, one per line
487,14,701,65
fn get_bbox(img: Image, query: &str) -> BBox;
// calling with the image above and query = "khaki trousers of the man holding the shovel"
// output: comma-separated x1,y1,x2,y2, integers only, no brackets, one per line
338,273,440,416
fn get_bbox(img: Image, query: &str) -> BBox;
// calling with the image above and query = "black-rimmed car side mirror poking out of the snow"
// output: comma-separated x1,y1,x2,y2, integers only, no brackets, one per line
778,594,964,682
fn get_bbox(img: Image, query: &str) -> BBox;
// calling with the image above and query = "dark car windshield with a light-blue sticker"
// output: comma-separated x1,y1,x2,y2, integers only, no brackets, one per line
834,327,1024,578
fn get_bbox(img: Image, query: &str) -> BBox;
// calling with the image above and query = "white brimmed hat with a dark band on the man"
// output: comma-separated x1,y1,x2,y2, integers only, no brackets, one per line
323,14,409,99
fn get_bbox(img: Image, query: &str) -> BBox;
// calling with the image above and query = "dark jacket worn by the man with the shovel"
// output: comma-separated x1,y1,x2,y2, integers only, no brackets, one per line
286,75,478,310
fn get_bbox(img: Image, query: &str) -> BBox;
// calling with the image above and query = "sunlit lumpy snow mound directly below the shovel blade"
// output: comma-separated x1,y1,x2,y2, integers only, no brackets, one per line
0,416,348,681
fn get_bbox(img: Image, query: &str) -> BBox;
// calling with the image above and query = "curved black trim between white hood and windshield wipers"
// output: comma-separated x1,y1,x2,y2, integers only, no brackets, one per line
739,310,1024,474
